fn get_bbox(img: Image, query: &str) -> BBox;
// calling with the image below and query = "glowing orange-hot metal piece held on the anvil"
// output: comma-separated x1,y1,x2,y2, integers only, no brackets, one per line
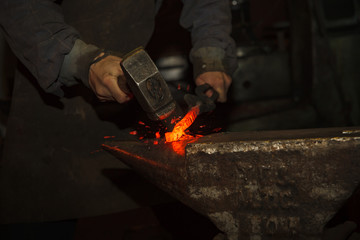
165,106,200,142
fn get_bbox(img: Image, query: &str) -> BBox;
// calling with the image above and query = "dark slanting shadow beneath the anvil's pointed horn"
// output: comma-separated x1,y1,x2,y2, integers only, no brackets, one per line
103,169,220,240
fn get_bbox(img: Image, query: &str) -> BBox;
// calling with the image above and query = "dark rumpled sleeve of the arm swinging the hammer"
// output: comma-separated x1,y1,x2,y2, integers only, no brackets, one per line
0,0,79,92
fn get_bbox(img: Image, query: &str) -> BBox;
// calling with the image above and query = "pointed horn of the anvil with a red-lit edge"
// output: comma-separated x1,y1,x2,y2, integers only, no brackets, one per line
103,140,187,202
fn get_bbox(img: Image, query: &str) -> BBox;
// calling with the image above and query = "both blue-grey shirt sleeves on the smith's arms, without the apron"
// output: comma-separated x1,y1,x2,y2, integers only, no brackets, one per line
0,0,236,94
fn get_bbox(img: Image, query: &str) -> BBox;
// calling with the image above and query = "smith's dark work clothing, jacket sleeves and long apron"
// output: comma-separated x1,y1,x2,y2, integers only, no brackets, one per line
0,0,234,223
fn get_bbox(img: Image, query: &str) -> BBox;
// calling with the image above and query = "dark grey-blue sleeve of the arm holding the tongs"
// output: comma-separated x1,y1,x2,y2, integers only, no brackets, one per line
180,0,236,77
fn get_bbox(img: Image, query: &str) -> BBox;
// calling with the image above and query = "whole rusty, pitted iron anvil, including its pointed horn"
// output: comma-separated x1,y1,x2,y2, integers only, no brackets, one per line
104,128,360,239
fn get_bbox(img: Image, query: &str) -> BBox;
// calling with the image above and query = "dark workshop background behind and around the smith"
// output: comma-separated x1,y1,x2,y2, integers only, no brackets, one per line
0,0,360,239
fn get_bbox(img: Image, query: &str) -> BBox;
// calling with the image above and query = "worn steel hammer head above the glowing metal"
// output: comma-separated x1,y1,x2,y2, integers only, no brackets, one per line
120,48,175,120
